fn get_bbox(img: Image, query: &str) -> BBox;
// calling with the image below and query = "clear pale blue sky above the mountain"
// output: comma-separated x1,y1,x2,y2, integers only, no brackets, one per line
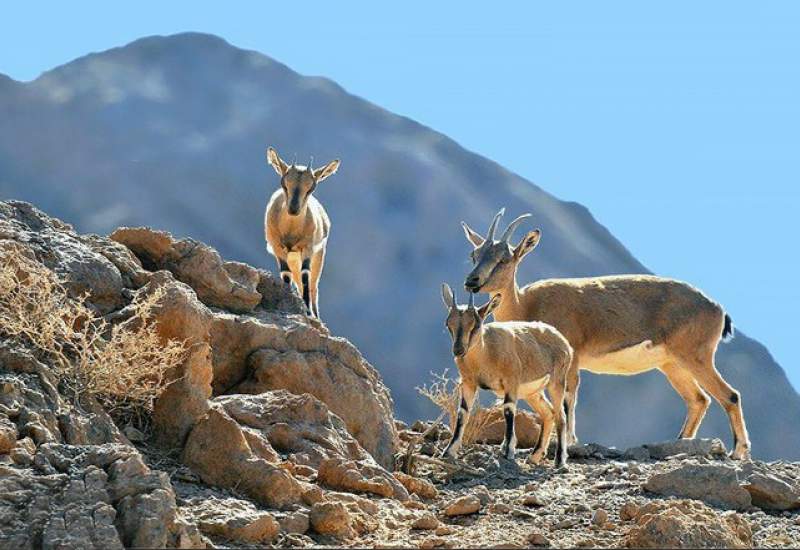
0,1,800,387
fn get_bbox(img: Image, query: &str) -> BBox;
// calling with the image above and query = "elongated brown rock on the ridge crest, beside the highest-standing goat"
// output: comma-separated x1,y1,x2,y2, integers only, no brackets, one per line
110,227,261,312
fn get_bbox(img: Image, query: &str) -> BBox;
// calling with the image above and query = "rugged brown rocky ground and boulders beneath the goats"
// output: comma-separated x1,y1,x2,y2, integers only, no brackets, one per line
0,202,800,548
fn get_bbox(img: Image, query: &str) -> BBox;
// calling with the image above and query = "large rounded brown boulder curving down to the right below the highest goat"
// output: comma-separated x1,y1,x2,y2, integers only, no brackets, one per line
238,340,397,468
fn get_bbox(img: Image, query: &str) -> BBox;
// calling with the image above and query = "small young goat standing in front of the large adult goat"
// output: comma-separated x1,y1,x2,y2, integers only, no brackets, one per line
442,284,572,467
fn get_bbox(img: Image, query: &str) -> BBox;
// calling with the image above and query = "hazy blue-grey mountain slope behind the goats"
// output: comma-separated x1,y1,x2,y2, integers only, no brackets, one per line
0,33,800,459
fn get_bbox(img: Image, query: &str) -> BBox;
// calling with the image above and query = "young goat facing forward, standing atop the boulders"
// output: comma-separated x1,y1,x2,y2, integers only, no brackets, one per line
264,147,339,318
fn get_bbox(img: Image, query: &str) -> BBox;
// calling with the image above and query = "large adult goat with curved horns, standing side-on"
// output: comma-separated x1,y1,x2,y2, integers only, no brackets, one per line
462,210,750,459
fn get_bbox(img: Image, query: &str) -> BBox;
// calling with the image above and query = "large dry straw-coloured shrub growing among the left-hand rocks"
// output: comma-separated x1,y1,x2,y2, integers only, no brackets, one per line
0,247,186,427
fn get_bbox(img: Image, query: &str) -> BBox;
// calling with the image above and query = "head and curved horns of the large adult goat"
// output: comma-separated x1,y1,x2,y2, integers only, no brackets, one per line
461,209,542,293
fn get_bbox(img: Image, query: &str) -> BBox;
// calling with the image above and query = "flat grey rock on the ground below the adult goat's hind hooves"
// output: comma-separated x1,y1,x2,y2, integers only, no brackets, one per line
644,464,752,510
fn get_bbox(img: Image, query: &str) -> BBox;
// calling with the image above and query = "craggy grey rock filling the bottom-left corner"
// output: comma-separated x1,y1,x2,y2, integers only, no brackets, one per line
0,443,195,548
